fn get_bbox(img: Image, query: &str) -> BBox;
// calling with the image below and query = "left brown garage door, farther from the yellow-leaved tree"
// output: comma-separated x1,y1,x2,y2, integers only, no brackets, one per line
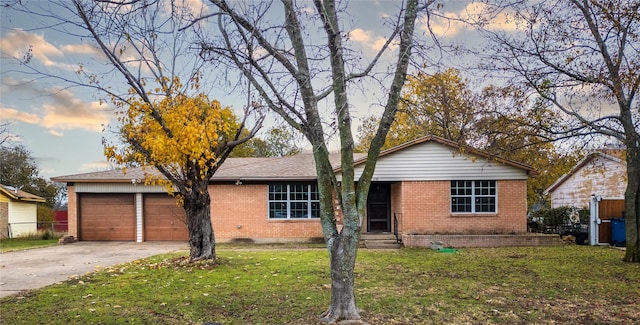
79,193,136,241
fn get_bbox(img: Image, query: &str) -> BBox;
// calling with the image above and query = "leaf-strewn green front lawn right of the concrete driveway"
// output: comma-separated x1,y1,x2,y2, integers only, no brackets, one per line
0,246,640,325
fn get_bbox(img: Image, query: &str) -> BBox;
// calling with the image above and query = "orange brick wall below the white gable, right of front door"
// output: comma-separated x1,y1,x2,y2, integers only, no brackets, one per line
392,180,527,234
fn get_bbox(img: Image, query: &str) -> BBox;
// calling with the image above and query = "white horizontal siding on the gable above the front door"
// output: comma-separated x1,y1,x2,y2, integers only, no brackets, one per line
348,142,528,182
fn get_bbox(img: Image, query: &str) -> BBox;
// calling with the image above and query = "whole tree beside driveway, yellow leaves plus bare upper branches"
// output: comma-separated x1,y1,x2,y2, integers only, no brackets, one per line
10,0,263,260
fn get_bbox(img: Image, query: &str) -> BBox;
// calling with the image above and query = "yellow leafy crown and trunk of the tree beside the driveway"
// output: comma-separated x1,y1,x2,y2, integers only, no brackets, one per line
104,79,260,261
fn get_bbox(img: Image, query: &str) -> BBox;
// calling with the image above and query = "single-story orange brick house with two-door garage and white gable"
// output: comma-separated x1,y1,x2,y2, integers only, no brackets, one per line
53,136,535,242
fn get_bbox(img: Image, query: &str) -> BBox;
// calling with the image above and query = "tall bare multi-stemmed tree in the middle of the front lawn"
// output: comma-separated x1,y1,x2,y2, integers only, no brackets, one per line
192,0,432,322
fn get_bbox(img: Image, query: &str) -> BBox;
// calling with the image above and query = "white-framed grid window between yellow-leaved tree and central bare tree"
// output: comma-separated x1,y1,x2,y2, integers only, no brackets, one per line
269,183,320,219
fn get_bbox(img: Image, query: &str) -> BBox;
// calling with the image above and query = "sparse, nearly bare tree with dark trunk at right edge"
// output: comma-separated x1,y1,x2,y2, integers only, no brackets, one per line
480,0,640,263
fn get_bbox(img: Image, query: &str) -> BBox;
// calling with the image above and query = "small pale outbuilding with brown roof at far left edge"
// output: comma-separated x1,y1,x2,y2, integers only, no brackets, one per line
0,184,46,238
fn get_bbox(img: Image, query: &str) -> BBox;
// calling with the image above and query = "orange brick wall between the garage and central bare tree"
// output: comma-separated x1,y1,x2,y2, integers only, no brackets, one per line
209,184,322,241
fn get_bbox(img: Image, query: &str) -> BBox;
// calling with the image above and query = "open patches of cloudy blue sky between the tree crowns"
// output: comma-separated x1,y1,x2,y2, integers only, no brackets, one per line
0,0,509,178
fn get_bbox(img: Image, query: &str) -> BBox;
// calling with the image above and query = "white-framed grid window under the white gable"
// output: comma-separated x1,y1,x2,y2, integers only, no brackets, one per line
451,181,497,213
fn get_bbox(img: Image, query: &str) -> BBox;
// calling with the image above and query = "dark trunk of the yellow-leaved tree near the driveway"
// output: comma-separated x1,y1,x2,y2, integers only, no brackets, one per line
183,182,216,262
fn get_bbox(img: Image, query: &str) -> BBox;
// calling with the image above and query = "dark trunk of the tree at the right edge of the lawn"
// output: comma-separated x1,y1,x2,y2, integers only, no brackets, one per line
624,141,640,263
